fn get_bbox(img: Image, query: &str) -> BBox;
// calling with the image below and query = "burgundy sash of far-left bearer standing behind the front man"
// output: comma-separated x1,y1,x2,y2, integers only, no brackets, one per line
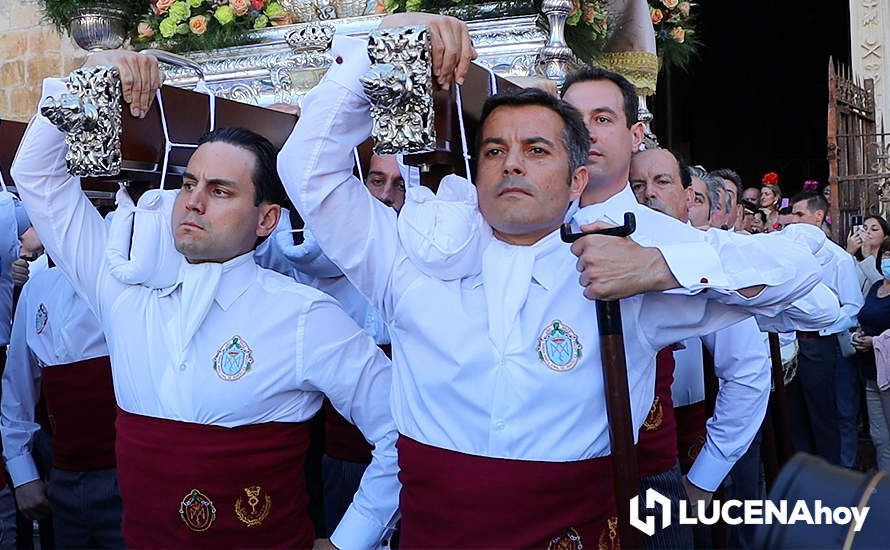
41,357,117,472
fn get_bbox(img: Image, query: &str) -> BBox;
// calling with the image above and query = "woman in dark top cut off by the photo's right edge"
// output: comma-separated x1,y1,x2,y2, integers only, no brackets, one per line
853,238,890,471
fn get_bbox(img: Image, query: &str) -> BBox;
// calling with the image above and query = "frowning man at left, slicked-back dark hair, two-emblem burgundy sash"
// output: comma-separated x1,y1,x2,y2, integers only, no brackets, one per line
13,51,399,548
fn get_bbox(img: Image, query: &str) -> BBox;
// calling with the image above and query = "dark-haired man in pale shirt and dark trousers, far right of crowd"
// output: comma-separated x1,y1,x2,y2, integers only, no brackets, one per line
789,190,864,468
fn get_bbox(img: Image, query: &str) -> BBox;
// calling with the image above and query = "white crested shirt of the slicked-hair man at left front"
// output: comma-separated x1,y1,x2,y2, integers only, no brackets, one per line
13,79,399,548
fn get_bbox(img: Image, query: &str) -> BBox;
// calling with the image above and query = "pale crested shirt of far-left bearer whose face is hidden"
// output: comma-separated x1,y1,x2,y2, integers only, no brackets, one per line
0,267,108,487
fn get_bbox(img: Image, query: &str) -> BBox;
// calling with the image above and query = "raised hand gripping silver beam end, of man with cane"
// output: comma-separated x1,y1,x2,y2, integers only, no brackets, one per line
380,12,476,90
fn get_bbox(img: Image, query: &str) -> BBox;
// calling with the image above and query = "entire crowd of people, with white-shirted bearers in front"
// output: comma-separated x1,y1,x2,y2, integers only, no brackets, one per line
0,10,876,549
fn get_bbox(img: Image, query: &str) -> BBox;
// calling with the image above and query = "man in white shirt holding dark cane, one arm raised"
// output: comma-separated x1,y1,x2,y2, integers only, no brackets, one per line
279,14,834,547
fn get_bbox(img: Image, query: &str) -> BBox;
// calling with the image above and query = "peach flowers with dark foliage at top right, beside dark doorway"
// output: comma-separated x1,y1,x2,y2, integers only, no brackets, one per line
649,0,701,69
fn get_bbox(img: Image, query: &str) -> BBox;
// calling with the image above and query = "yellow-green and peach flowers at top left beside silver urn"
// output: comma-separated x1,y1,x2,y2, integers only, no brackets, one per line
133,0,293,51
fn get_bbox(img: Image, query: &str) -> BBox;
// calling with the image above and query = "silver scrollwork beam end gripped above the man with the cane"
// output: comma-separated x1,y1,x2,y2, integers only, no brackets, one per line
362,25,436,155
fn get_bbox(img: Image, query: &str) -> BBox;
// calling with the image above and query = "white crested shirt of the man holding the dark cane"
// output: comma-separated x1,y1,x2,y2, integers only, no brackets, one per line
278,37,834,468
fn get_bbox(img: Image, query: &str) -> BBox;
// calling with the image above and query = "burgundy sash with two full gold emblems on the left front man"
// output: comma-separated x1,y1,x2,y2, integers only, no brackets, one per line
117,410,315,548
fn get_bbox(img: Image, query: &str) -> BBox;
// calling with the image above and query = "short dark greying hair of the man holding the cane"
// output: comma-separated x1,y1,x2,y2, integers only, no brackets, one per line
476,88,590,176
